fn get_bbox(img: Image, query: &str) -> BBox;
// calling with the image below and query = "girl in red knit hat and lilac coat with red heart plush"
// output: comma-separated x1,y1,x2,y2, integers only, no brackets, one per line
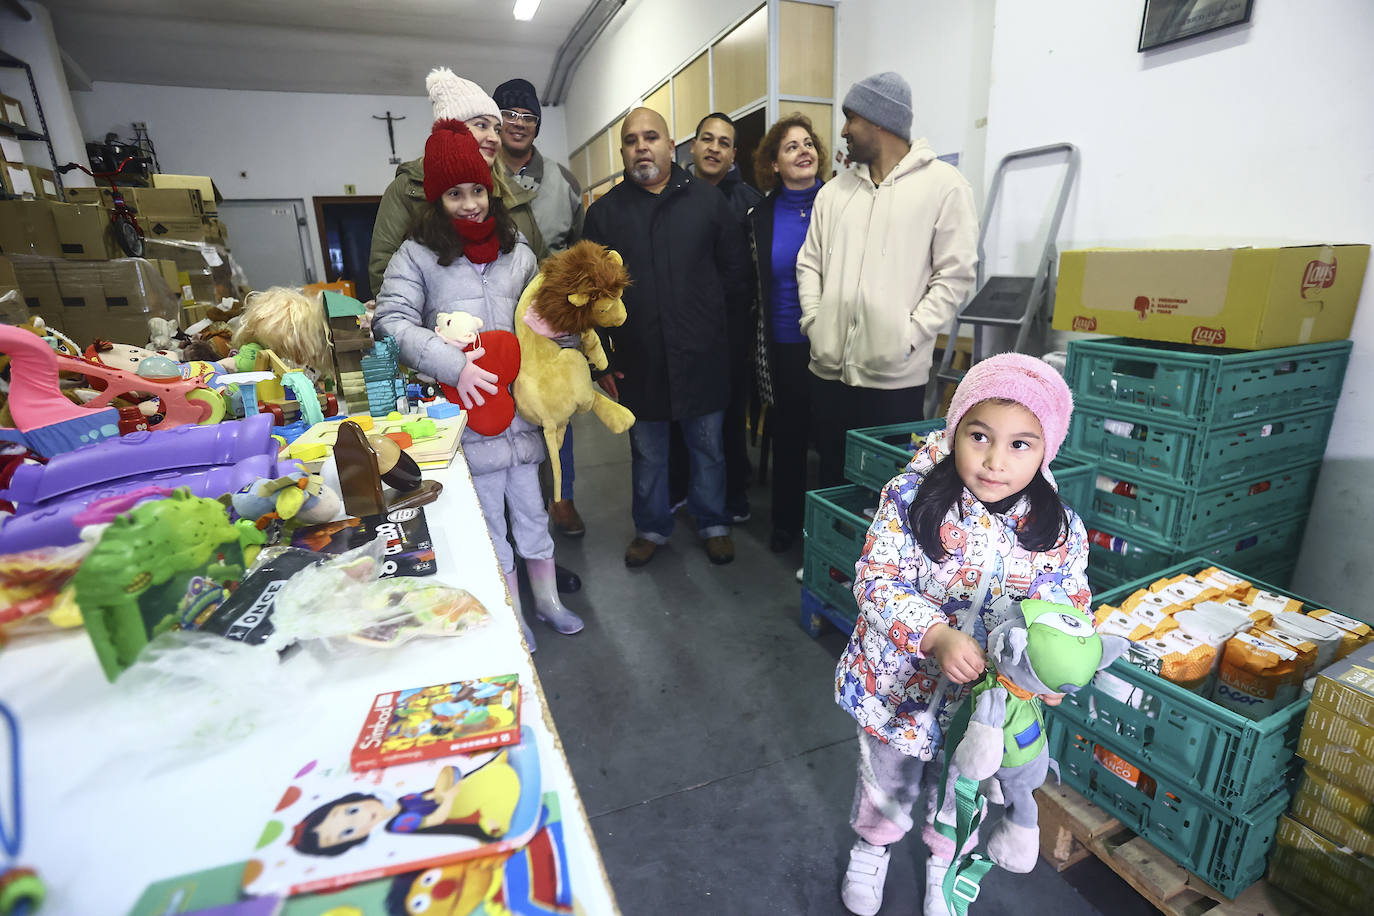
374,100,583,650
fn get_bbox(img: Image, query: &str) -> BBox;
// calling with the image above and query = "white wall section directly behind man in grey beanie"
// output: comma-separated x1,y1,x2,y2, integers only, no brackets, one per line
835,0,993,206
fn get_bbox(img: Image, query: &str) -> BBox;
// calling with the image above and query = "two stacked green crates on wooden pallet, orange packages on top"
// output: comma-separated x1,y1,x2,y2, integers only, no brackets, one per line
1046,558,1318,897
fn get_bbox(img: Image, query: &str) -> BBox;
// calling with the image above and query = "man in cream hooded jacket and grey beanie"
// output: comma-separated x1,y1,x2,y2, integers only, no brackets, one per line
797,73,978,486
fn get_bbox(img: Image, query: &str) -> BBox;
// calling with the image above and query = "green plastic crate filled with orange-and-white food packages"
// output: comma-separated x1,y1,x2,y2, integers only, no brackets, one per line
1059,558,1322,810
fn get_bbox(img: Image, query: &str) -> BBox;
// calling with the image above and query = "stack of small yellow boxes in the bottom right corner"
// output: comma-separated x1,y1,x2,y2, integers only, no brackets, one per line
1270,643,1374,913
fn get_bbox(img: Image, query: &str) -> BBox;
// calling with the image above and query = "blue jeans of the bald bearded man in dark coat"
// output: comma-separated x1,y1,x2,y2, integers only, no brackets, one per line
629,411,730,544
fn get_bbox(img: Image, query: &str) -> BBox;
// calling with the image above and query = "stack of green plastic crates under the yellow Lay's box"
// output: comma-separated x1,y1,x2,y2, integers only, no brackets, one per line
1062,338,1351,589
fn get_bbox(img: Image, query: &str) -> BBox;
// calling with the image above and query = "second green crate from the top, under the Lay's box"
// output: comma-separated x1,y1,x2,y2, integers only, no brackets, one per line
1066,405,1336,490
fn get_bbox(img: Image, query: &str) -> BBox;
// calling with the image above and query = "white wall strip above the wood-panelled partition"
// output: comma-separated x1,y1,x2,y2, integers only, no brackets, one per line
563,0,761,148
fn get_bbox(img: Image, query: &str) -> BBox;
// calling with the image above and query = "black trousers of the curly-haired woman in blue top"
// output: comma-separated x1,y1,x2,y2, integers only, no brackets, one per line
764,342,812,534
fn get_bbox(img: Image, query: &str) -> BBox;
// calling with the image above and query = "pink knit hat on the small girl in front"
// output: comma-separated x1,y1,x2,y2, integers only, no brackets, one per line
945,353,1073,470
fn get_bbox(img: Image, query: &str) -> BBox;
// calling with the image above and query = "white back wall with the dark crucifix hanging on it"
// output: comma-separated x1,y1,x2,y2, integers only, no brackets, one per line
71,82,567,284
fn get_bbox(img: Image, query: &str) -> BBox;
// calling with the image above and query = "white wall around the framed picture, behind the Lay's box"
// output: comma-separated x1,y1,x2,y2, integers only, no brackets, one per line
985,0,1374,619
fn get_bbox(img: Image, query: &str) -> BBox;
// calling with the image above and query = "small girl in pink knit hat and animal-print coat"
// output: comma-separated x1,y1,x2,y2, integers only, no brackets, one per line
835,353,1091,916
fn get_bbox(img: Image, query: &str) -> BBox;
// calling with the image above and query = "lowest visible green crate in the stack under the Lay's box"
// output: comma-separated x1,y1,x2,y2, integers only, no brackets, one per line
1088,511,1307,582
